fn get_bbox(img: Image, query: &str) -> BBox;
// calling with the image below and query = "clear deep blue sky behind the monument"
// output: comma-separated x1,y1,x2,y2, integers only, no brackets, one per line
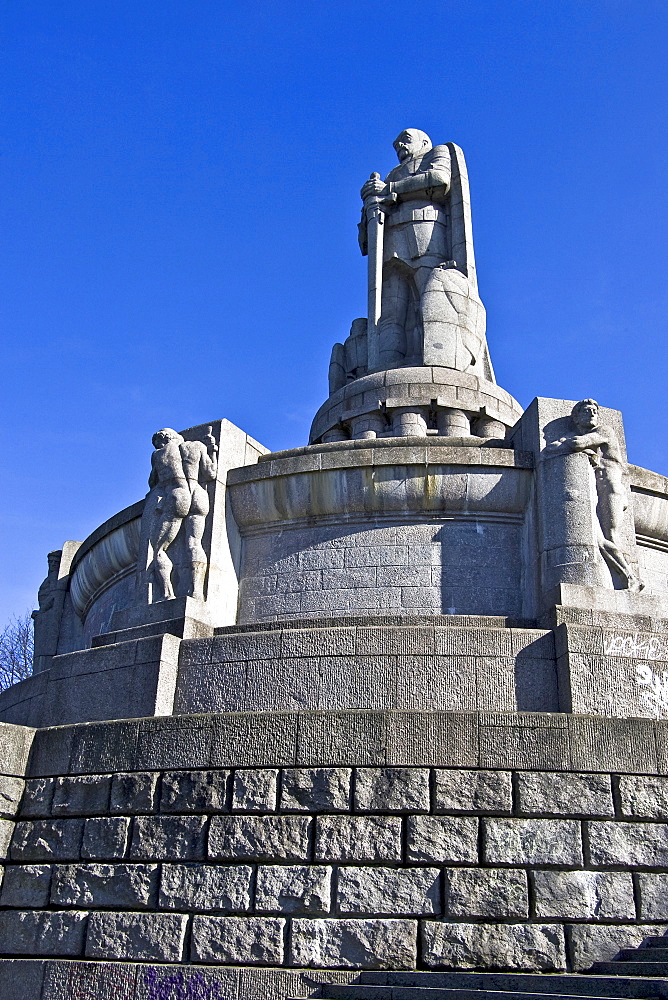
0,0,668,623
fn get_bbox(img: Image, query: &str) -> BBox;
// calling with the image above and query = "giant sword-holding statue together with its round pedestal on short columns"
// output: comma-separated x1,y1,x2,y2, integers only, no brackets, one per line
311,128,520,442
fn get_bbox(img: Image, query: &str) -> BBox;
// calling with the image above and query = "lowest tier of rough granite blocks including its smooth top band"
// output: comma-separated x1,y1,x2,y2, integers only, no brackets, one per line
0,711,668,996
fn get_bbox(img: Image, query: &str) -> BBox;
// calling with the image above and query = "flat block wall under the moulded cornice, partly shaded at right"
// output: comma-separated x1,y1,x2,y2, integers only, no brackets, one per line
238,515,522,622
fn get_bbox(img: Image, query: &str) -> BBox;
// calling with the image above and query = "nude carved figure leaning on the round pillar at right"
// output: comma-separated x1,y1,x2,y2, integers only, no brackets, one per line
544,399,644,593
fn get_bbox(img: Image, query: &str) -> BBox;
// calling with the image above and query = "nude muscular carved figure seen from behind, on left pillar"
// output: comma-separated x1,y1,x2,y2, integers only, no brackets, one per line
146,427,218,603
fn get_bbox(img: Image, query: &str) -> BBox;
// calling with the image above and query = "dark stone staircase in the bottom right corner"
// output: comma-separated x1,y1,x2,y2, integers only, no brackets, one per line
312,968,668,1000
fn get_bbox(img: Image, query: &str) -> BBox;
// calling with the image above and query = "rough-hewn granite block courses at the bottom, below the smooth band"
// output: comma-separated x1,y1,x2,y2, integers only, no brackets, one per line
0,766,668,971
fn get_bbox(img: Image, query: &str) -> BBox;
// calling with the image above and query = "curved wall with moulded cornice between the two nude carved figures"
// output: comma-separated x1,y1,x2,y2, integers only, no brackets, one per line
228,439,532,622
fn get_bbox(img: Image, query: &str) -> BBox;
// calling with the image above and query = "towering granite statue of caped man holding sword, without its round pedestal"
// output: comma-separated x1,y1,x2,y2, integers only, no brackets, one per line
339,128,494,381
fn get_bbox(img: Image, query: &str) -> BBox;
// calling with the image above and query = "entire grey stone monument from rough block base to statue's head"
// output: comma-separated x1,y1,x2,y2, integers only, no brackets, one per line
0,129,668,1000
